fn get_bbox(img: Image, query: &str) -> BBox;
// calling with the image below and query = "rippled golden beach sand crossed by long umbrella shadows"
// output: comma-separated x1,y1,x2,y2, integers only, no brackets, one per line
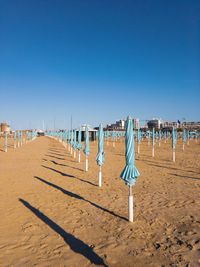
0,137,200,267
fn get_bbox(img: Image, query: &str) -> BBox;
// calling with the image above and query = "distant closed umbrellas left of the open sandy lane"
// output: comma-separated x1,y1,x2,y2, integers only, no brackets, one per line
2,131,37,152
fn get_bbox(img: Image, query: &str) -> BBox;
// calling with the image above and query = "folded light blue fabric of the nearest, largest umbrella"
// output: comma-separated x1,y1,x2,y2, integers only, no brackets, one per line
120,117,140,186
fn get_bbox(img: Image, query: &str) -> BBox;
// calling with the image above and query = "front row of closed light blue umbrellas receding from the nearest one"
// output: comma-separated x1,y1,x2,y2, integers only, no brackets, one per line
46,117,139,222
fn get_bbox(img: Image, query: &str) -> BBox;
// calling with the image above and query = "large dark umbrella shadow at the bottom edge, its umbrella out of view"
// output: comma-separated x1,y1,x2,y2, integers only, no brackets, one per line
19,198,107,267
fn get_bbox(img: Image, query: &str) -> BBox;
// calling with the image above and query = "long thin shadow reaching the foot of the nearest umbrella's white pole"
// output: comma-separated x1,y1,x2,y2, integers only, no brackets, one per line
34,176,127,221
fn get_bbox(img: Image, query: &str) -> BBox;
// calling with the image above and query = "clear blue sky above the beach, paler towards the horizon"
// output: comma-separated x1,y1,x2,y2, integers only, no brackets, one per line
0,0,200,128
